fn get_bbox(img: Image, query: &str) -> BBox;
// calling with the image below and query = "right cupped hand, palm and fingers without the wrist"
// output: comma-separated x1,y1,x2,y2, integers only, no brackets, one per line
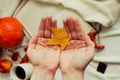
60,17,94,73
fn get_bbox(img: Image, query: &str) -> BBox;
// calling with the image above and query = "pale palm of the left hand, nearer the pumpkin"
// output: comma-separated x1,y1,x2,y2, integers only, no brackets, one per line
28,38,59,67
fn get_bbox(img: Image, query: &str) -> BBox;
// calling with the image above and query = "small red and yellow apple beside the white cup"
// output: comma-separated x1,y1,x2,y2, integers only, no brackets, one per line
0,59,12,73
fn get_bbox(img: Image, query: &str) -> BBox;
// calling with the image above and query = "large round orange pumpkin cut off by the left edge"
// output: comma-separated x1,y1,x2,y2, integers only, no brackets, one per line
0,17,24,48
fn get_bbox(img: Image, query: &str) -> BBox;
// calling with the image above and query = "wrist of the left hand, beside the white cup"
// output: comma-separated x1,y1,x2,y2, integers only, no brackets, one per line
30,67,54,80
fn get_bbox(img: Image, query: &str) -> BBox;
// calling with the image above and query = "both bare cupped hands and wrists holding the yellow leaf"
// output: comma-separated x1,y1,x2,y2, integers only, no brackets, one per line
27,16,94,80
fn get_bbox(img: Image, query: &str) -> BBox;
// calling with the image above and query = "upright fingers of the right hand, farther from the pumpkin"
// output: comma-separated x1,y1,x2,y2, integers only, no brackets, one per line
63,17,85,40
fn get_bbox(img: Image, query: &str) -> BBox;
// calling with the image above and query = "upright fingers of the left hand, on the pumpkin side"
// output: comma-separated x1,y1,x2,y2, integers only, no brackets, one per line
38,16,57,38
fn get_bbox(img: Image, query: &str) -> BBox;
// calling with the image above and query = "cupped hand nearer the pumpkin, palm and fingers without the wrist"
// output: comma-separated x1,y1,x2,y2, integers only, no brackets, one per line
27,16,60,72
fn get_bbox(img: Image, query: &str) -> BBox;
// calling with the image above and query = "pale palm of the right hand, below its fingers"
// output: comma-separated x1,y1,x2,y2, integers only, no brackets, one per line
60,41,93,71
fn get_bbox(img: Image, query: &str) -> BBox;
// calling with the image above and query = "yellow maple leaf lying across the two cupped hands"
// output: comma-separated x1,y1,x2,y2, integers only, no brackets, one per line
47,28,69,50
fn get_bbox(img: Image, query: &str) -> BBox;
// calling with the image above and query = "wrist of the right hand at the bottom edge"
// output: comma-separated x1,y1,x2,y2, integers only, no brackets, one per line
62,70,84,80
